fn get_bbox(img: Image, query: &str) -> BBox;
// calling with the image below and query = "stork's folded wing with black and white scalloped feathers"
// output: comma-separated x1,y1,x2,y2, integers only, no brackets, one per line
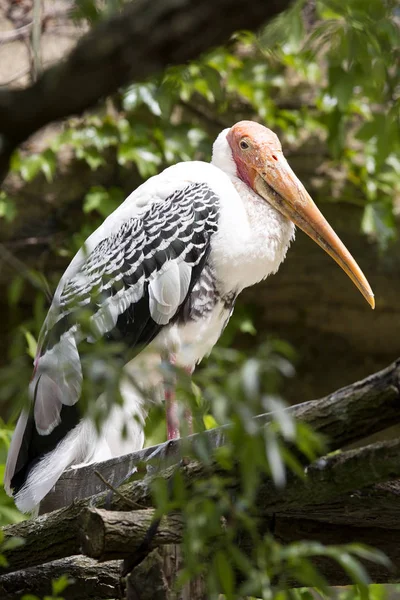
6,183,219,491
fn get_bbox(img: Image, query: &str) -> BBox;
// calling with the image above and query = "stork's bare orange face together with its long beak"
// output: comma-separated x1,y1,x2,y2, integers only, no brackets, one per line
227,121,375,308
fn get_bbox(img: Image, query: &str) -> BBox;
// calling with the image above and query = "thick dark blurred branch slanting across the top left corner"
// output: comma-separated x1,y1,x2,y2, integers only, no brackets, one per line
0,0,290,179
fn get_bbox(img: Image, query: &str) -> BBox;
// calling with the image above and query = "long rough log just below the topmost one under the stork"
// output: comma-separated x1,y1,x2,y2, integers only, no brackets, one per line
3,440,400,572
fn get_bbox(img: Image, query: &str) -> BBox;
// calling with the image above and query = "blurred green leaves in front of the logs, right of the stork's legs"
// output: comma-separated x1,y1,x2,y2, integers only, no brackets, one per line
145,340,389,600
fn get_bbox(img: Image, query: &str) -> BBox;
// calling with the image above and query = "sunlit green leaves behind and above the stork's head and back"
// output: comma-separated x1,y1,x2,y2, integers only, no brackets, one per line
7,0,400,249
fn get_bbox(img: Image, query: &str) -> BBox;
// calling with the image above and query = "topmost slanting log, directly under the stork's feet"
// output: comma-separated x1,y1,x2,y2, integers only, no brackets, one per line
41,360,400,512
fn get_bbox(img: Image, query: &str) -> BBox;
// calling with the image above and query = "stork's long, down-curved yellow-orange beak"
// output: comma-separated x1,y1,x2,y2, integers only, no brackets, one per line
253,152,375,308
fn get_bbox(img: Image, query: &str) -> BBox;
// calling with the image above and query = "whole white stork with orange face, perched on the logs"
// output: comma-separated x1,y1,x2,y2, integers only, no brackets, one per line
5,121,374,512
